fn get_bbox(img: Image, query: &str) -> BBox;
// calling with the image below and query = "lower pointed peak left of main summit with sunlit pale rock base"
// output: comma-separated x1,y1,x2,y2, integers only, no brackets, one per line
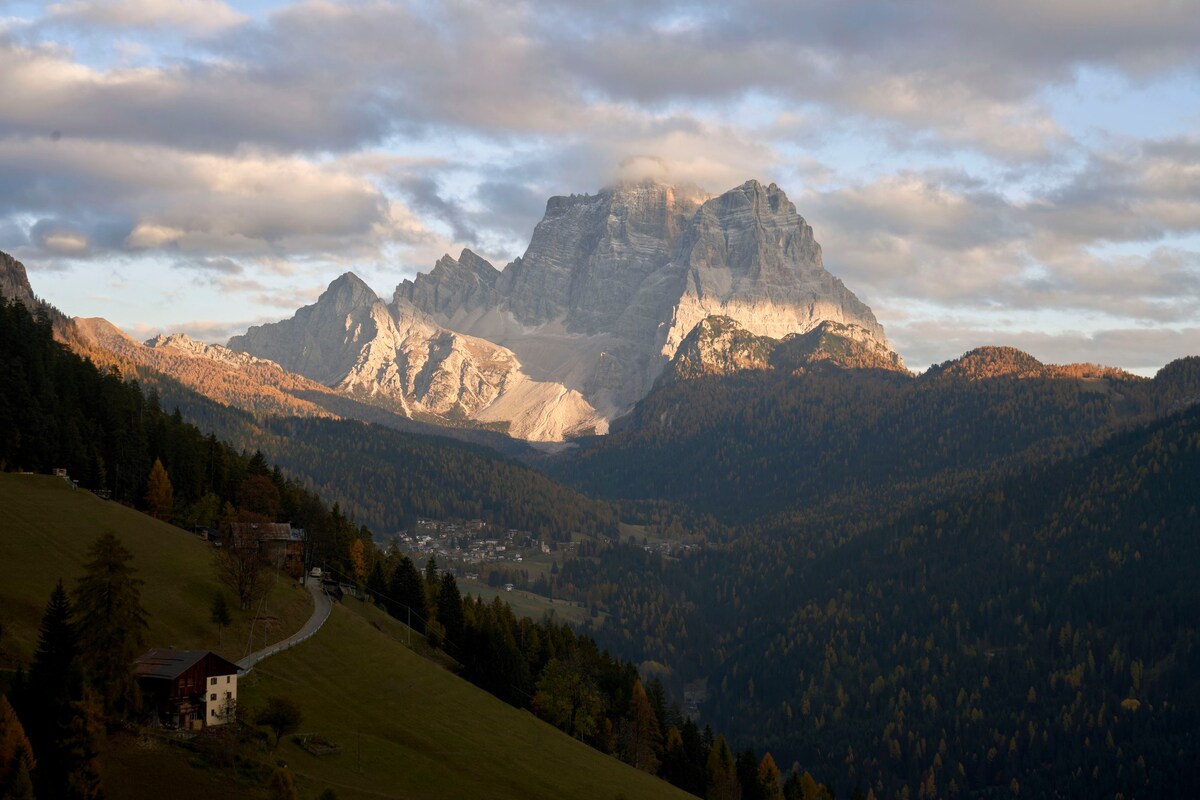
229,273,605,440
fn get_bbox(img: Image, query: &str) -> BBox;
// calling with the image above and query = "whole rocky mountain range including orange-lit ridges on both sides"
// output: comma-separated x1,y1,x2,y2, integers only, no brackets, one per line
0,180,1190,452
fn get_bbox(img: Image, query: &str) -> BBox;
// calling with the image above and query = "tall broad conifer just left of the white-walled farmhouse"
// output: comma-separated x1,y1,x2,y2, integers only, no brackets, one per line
74,531,148,722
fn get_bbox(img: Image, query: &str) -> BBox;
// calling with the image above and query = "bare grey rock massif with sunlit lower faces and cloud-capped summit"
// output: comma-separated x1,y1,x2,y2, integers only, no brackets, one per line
229,180,902,439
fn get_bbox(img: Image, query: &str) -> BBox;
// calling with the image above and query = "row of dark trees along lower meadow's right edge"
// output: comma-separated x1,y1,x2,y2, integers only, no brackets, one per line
359,549,833,800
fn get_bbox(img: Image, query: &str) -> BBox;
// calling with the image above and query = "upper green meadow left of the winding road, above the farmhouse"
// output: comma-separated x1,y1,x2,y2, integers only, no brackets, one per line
0,473,312,668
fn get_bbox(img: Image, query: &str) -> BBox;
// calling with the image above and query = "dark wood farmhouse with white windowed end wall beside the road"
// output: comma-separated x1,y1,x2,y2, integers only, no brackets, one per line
134,648,238,730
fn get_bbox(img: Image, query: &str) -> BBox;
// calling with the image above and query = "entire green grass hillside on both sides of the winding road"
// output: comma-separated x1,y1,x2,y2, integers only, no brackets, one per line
0,474,689,800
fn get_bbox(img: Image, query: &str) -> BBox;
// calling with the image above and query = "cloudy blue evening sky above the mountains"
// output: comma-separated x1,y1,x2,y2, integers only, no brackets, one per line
0,0,1200,374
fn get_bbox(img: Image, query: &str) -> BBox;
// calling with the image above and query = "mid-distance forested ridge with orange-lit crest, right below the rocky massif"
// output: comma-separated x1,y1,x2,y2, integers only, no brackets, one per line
547,348,1200,523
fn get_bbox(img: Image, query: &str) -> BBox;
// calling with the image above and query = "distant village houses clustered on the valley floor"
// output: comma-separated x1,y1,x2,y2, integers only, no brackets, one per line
396,519,551,566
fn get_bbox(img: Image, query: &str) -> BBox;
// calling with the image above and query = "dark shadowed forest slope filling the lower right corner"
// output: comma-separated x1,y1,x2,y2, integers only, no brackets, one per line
560,409,1200,798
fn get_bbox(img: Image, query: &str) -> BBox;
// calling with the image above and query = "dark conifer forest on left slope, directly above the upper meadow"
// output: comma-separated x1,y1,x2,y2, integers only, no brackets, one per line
0,297,368,573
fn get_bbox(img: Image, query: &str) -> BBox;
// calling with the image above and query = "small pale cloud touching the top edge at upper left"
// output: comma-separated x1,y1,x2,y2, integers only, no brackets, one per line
48,0,246,34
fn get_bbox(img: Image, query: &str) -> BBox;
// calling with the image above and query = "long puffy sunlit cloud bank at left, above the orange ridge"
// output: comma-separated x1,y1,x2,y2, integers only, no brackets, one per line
0,139,422,259
